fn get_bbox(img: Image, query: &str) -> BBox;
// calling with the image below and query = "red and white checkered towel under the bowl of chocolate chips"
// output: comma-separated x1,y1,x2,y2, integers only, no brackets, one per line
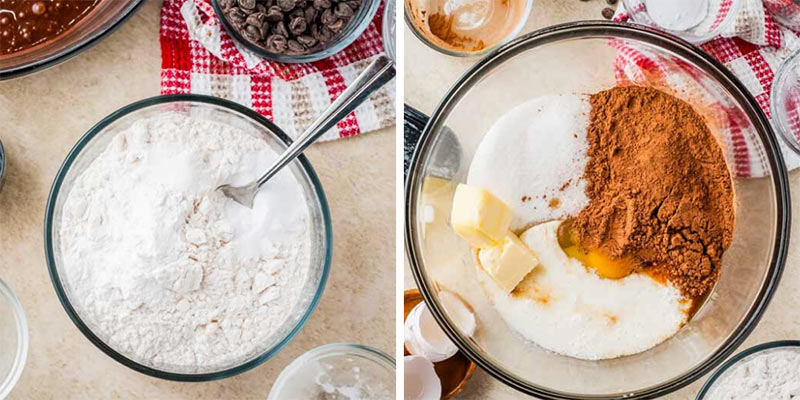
160,0,395,140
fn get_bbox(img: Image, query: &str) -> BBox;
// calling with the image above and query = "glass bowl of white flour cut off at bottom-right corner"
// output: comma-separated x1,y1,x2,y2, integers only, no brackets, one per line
697,340,800,400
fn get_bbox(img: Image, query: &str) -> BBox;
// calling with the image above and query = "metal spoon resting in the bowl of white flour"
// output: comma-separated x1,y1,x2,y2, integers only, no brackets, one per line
217,56,395,208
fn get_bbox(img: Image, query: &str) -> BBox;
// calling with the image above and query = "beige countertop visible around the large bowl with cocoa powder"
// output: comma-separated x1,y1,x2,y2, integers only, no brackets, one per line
403,0,800,400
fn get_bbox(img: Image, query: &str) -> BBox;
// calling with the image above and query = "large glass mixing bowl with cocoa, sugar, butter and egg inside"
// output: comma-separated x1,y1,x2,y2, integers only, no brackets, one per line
405,21,790,400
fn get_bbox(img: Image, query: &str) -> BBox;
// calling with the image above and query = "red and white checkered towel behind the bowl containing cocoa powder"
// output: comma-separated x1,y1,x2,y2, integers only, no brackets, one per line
612,0,800,177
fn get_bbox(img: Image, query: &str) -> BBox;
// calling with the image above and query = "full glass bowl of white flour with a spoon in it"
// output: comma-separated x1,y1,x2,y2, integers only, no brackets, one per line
45,95,331,381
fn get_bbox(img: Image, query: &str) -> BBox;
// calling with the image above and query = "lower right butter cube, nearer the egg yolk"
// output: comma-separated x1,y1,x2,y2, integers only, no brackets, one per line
478,232,539,292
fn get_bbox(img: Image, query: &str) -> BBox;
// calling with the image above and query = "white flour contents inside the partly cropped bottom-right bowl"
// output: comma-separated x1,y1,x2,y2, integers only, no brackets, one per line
708,348,800,400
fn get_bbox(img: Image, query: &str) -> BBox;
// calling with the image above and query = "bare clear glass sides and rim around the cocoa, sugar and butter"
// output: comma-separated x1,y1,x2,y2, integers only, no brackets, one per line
405,22,790,399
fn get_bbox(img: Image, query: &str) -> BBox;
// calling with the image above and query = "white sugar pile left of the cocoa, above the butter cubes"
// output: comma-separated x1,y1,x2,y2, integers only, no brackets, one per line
467,94,590,231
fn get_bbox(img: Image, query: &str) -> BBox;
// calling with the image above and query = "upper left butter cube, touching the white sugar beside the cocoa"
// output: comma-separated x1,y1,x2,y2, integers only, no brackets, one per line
450,184,513,248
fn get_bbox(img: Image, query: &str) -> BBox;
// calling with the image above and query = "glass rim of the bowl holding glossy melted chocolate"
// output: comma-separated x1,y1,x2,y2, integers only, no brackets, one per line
0,0,144,80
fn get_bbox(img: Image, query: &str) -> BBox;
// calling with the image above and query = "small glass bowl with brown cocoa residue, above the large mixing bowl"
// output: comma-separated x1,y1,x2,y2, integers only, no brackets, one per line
405,0,533,57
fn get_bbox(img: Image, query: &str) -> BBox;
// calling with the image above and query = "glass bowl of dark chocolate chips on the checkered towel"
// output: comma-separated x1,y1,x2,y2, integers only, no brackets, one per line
211,0,380,63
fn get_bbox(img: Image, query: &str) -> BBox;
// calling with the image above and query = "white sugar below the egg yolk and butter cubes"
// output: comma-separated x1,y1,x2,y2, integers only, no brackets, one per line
477,221,689,360
